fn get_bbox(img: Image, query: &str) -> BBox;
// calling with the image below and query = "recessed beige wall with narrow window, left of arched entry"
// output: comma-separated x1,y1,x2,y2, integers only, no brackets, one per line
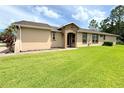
51,32,64,48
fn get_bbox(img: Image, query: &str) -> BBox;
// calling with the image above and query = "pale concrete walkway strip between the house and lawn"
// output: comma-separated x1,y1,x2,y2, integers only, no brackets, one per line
0,48,77,57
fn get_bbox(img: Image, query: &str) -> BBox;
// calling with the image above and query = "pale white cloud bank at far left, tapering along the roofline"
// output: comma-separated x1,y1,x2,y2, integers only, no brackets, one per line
0,6,58,29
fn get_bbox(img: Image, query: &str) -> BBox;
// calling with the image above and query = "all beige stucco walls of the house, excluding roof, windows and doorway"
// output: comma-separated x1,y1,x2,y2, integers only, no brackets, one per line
15,26,116,52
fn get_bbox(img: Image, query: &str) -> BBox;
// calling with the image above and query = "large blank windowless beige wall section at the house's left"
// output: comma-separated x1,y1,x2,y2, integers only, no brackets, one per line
21,27,51,51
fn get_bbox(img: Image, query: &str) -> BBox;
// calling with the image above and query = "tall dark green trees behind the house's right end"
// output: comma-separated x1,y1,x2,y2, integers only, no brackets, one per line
100,5,124,42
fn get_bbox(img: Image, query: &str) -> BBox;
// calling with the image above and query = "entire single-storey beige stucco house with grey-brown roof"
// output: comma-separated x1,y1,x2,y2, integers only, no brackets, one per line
12,21,117,52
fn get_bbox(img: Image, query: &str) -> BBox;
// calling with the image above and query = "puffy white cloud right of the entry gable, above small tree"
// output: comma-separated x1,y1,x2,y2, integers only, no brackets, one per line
72,6,106,22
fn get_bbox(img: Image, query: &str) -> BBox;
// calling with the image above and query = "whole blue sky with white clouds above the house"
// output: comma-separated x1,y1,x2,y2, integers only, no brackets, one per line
0,5,115,29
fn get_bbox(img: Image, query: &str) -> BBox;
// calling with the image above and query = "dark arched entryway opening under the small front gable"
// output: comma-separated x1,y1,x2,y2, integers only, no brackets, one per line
67,33,75,47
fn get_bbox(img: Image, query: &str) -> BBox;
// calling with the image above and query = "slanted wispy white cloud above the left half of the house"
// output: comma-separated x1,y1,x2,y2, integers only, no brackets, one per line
35,6,61,18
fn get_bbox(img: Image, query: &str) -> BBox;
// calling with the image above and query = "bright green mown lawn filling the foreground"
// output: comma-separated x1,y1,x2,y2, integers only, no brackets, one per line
0,45,124,88
